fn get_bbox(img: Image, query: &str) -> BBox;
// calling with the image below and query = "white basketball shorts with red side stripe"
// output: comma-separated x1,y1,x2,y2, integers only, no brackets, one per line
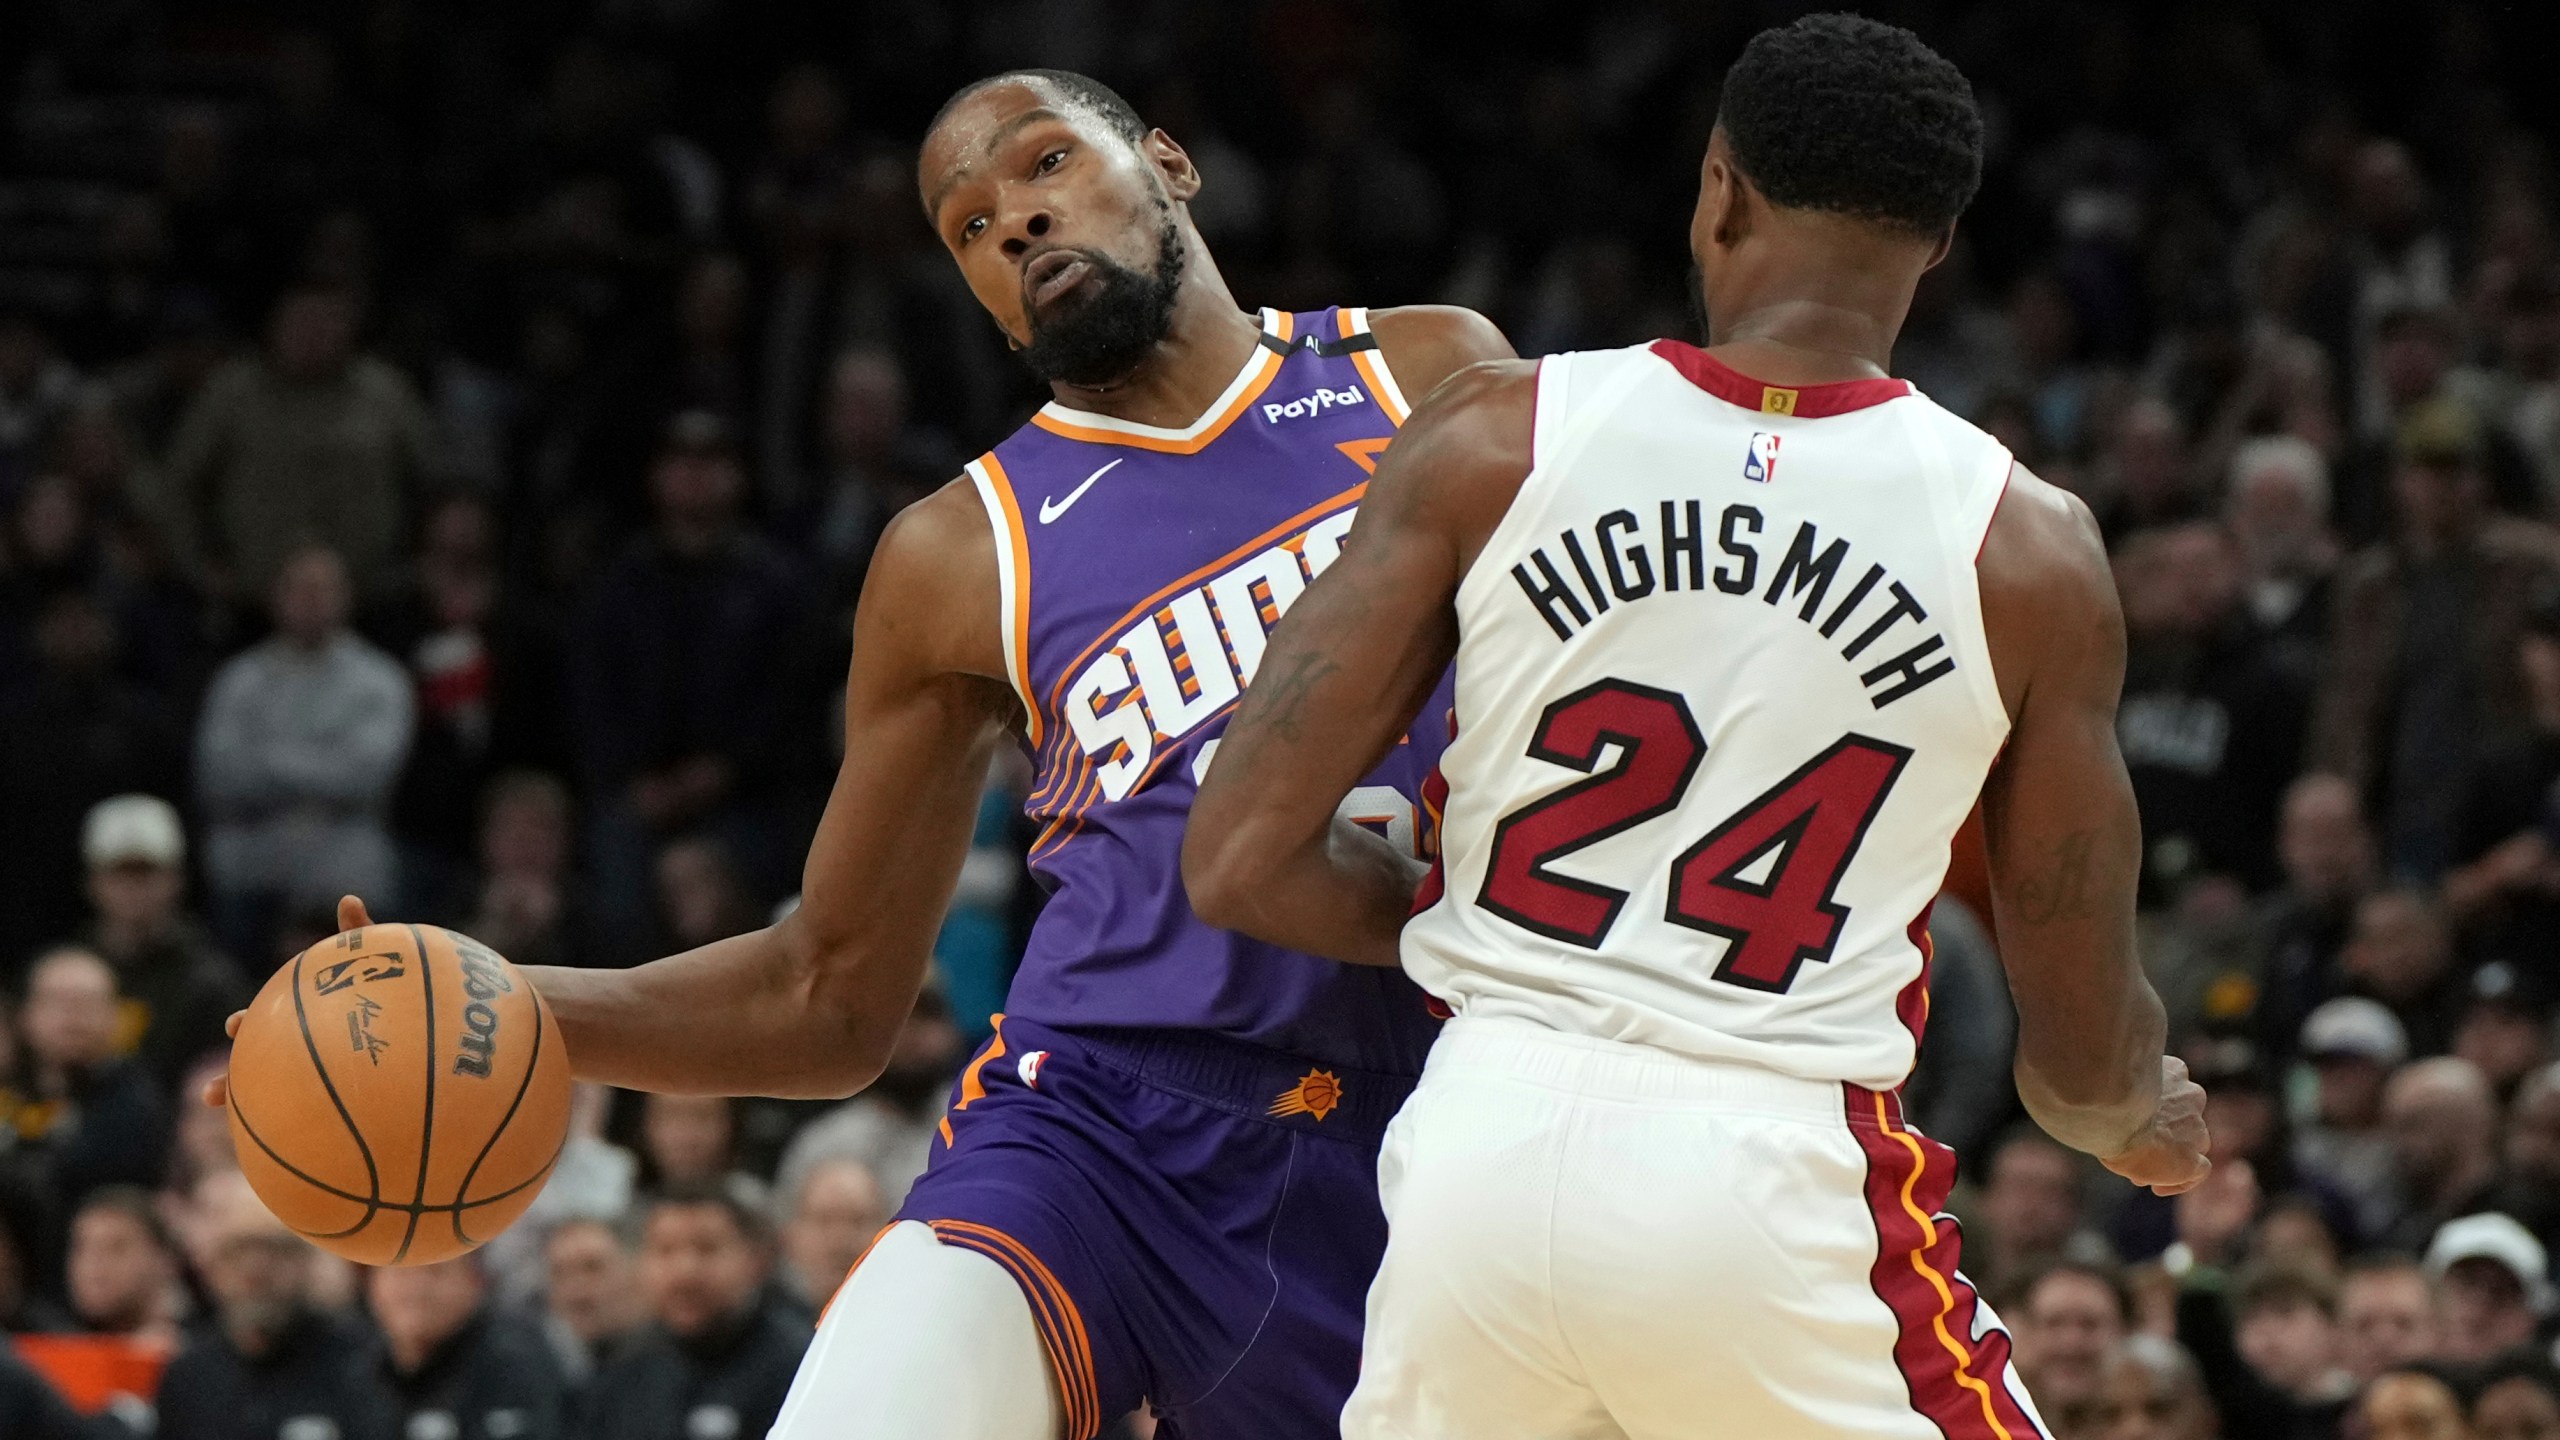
1341,1017,2045,1440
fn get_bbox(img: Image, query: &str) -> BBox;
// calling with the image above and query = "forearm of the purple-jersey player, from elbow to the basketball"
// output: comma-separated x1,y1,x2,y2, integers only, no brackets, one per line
525,920,906,1099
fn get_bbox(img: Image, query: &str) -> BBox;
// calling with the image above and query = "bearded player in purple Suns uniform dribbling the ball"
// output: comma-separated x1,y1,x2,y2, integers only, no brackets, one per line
230,72,1510,1440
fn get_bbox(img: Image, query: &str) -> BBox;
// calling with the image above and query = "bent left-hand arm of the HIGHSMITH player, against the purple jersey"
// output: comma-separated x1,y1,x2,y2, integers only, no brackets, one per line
1183,361,1536,966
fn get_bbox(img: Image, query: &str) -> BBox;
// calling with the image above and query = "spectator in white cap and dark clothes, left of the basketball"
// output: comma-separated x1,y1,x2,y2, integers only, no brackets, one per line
79,794,251,1094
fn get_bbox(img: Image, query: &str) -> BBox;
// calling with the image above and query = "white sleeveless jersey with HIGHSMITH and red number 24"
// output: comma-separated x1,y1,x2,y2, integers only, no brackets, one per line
1403,341,2010,1089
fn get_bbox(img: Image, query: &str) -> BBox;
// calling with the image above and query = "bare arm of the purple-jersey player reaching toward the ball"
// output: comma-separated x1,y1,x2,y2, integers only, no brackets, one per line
527,487,1019,1099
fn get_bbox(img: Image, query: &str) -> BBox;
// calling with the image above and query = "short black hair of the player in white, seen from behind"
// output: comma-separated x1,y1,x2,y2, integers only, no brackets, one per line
1715,15,1981,236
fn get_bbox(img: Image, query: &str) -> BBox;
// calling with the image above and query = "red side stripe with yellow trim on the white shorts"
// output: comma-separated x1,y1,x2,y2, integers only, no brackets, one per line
1841,1086,2045,1440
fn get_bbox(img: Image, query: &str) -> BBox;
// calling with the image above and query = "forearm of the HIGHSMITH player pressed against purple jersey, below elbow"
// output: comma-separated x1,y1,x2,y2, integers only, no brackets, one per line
1183,820,1423,969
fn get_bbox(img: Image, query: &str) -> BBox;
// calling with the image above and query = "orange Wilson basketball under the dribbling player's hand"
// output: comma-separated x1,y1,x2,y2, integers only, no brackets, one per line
230,925,568,1266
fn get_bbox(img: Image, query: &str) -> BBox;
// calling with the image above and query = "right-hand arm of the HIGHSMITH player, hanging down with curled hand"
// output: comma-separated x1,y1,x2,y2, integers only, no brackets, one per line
1979,469,2207,1194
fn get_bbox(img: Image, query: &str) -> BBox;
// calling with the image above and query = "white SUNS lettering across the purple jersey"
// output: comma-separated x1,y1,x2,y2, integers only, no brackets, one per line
1060,505,1357,799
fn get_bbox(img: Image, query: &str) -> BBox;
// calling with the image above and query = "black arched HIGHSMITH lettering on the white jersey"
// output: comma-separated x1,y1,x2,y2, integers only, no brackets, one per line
1510,500,1956,710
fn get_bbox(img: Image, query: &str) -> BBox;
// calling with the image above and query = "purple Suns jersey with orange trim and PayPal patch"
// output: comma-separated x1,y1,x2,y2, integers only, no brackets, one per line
968,307,1449,1074
